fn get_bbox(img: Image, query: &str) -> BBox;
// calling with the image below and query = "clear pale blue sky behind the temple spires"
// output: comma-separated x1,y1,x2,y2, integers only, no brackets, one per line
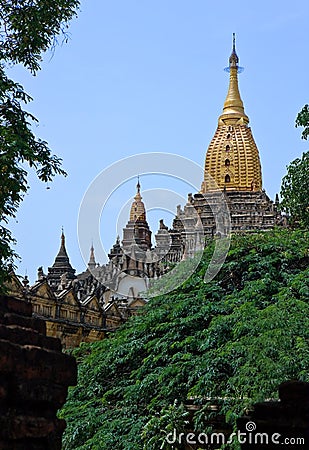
10,0,309,282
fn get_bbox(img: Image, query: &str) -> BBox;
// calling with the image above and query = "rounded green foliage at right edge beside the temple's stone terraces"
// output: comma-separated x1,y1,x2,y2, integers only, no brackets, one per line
280,152,309,228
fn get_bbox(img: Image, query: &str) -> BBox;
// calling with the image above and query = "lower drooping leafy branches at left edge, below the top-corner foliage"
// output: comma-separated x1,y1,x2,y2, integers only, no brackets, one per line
0,66,65,283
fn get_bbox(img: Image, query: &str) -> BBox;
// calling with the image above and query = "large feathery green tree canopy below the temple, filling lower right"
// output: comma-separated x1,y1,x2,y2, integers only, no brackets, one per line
60,230,309,450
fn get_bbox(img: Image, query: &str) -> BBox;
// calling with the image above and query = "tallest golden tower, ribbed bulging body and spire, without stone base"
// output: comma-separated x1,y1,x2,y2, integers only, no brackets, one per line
201,34,262,193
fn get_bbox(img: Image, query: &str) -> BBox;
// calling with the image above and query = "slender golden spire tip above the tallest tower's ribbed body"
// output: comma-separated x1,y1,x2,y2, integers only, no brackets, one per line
219,33,249,125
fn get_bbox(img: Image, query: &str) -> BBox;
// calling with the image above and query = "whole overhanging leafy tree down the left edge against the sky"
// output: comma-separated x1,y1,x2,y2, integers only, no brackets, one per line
0,0,79,289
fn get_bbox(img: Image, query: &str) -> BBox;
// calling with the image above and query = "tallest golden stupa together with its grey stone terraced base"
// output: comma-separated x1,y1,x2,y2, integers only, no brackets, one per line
171,34,282,248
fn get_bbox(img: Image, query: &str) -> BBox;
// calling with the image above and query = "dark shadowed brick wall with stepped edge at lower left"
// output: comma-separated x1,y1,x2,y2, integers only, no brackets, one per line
0,296,77,450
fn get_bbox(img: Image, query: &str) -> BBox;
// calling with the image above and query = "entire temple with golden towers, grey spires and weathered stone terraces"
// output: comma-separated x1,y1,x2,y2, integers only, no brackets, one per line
7,35,284,347
